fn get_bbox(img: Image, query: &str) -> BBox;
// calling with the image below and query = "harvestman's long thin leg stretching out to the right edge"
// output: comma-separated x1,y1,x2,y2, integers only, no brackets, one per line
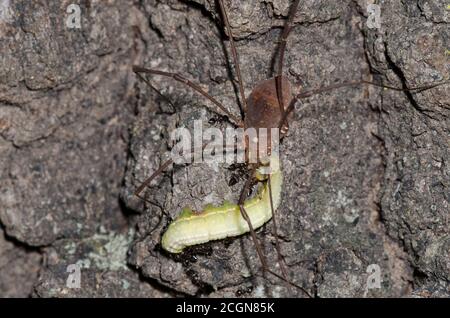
278,80,450,129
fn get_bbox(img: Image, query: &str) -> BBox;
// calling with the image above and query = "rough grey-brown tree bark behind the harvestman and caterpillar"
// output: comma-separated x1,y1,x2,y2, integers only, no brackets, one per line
0,0,450,297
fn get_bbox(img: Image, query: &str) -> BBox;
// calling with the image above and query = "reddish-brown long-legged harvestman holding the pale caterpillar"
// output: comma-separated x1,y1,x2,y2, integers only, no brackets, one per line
133,0,448,297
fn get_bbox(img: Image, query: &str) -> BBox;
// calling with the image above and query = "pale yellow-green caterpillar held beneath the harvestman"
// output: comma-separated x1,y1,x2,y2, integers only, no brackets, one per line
161,155,283,253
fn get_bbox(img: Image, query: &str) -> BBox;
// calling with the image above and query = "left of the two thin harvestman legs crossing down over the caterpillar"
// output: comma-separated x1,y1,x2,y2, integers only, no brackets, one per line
238,169,311,298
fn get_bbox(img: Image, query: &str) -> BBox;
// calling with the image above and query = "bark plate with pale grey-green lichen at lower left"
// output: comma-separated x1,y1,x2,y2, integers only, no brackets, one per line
35,230,169,297
